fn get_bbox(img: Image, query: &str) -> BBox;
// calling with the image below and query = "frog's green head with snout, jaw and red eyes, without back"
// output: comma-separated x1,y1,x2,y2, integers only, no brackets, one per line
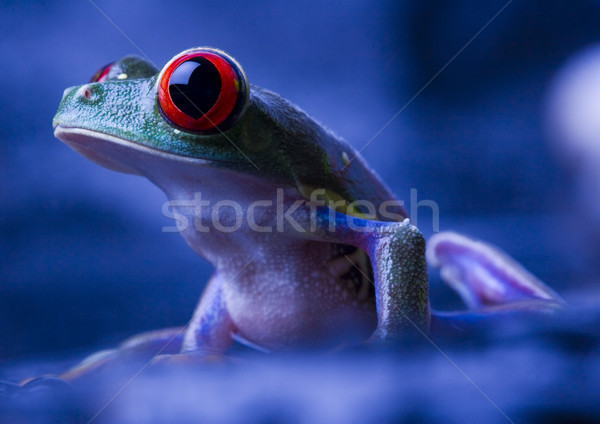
53,48,250,175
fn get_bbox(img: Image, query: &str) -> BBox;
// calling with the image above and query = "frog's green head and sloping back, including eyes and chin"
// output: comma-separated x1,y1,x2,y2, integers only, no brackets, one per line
53,47,406,219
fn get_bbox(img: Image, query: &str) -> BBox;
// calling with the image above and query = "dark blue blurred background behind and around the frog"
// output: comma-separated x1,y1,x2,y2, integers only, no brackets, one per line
0,0,600,420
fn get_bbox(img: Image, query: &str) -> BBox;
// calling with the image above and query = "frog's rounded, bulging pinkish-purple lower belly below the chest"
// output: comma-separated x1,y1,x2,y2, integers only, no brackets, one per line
223,242,377,350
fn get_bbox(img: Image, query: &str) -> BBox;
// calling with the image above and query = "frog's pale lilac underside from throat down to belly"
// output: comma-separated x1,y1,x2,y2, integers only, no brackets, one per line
146,154,377,350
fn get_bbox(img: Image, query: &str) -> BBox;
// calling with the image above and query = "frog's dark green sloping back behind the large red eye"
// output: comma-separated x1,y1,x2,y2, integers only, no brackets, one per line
250,86,407,221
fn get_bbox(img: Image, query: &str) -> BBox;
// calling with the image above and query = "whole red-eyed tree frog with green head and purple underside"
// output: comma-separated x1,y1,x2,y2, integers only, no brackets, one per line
45,47,566,381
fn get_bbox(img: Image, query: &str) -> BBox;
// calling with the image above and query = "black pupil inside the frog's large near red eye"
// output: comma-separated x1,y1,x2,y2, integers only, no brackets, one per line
169,57,221,119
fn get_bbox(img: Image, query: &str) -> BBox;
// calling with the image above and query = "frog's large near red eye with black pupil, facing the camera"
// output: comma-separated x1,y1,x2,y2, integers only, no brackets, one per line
158,48,248,133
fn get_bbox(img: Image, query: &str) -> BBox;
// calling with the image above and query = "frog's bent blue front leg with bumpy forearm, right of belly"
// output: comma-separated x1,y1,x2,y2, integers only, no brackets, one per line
308,208,431,340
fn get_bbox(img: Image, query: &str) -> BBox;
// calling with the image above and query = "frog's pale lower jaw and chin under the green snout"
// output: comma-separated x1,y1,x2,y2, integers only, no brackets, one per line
54,125,212,175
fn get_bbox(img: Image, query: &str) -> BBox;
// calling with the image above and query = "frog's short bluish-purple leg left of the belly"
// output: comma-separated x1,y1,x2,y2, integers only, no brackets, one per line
181,274,235,353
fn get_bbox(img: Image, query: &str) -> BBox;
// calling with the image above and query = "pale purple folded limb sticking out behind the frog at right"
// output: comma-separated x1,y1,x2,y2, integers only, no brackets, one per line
427,232,566,310
